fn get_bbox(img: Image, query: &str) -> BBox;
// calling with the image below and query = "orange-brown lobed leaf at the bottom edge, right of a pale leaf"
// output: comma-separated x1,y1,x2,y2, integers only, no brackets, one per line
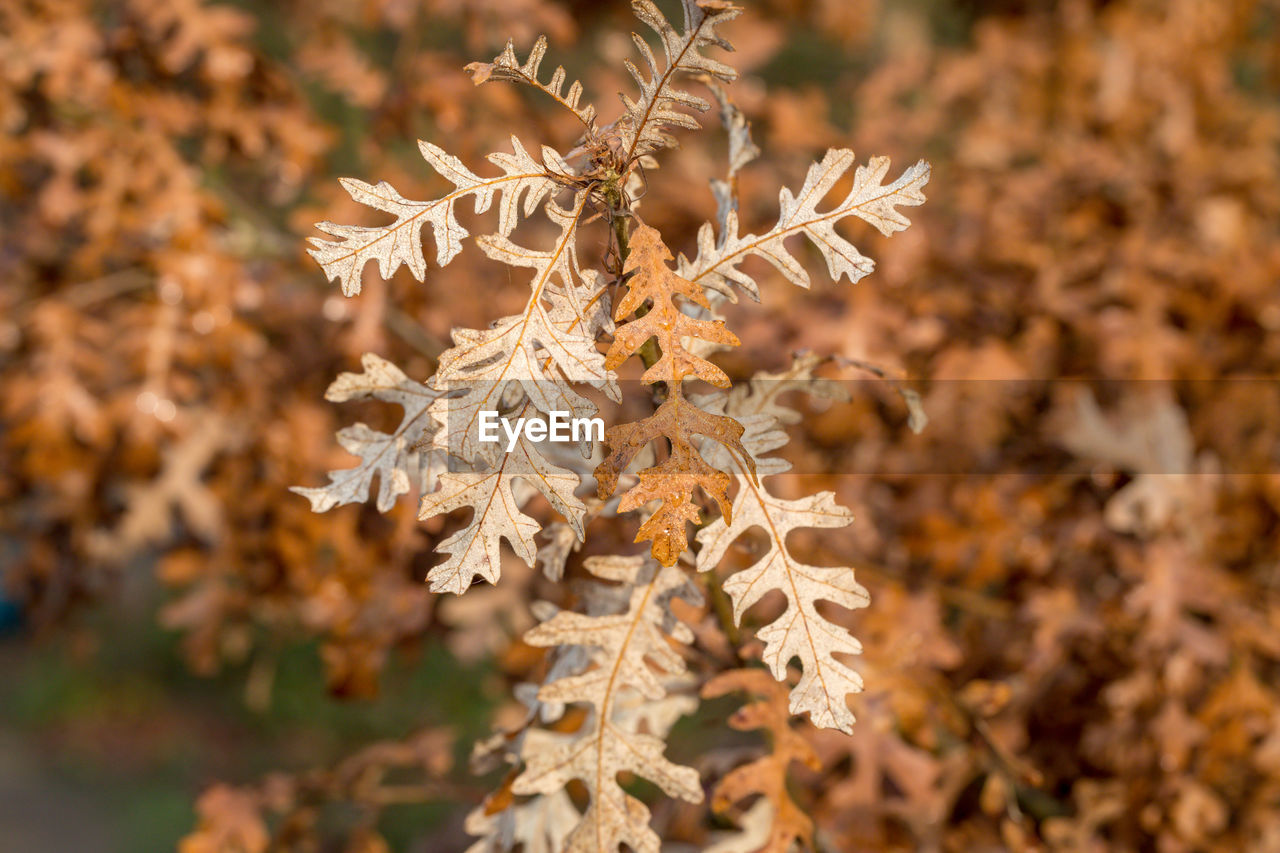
703,670,820,853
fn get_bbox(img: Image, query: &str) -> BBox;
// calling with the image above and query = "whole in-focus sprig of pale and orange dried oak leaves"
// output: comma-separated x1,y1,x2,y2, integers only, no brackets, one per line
286,0,928,835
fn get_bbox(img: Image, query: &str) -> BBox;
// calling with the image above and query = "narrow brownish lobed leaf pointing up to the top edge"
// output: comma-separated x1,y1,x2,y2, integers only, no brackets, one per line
616,0,742,161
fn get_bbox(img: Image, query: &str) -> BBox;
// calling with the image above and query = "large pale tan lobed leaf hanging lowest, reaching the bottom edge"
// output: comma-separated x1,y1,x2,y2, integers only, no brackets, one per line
512,557,703,853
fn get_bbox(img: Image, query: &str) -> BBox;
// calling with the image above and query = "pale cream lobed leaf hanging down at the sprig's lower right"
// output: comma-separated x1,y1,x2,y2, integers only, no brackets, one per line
696,357,868,731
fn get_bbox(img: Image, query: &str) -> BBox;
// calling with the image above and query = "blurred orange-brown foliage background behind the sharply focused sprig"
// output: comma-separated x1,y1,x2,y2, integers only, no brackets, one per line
0,0,1280,853
